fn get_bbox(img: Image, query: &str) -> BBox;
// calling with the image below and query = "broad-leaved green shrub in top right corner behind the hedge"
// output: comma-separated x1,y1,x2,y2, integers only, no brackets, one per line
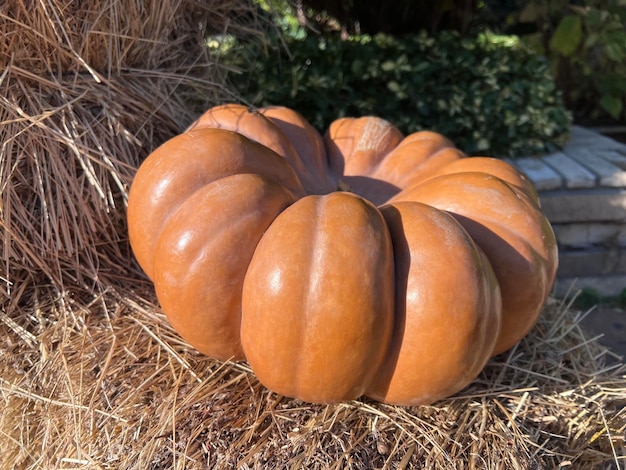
487,0,626,124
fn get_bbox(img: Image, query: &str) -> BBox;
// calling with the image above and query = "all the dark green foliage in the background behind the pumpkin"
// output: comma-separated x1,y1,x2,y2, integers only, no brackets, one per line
216,0,626,156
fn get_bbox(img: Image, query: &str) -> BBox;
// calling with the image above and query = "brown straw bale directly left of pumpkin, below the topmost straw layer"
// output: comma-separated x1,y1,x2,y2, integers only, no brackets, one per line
0,66,178,290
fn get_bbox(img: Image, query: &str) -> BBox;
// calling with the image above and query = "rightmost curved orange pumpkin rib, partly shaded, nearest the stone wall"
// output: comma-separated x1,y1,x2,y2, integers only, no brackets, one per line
392,172,558,354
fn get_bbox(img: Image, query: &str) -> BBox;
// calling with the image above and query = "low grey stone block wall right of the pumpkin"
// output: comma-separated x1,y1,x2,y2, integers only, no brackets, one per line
510,126,626,296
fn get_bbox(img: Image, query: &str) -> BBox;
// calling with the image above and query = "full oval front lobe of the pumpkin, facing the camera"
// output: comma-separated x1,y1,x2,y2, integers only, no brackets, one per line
241,193,394,403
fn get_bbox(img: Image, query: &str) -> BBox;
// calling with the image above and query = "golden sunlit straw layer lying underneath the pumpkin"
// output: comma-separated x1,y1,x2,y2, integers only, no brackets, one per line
0,284,626,469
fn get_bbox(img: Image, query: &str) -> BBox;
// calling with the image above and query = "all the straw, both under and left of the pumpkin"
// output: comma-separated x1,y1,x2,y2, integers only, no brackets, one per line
0,0,626,469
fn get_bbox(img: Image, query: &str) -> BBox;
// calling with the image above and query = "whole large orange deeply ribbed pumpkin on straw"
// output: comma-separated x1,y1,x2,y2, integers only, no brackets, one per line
128,104,558,405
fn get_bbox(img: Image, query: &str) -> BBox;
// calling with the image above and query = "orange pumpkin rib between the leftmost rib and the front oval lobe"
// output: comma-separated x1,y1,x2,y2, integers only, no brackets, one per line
154,174,296,360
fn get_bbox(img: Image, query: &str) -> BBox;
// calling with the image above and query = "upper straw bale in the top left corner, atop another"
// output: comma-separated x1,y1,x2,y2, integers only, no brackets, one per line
0,0,246,74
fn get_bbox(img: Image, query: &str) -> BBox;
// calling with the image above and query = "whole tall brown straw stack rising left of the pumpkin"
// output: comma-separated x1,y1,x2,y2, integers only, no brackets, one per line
0,0,254,305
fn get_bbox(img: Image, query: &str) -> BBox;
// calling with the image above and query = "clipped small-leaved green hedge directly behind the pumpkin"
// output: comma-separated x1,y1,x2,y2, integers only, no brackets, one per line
222,32,571,157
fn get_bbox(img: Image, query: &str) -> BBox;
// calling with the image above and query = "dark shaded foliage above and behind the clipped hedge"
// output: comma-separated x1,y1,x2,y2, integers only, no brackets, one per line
301,0,626,124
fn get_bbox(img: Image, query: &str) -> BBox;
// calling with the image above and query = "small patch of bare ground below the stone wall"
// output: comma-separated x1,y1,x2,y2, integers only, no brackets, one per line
582,305,626,358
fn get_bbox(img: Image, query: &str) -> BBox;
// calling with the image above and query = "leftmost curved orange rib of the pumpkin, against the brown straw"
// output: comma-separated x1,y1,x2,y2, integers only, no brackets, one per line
127,129,305,279
